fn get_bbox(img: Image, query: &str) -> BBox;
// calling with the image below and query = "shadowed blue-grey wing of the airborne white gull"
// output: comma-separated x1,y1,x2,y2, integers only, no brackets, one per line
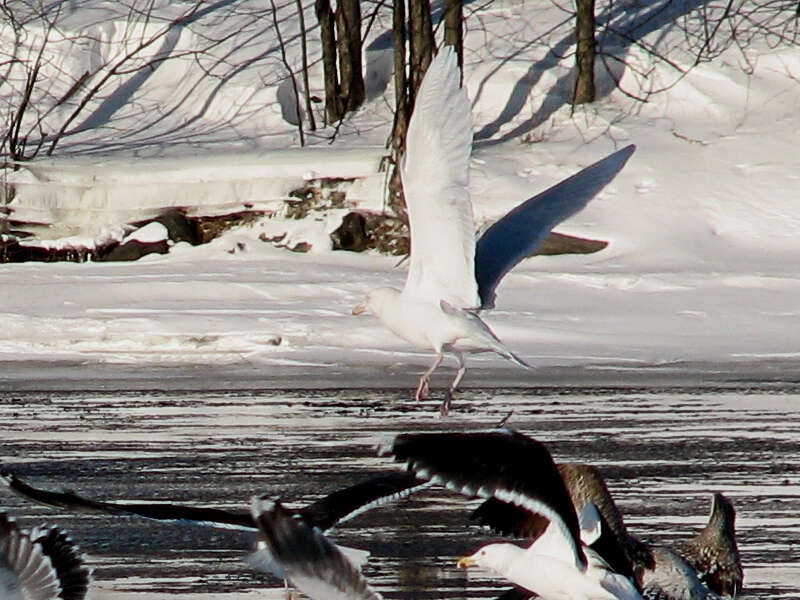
475,144,636,308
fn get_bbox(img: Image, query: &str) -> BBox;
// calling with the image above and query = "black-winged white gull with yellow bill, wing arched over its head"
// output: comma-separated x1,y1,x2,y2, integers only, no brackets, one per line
382,429,642,600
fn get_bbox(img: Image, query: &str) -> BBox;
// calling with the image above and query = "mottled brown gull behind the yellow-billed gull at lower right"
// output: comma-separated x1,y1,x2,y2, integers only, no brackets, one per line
472,463,742,600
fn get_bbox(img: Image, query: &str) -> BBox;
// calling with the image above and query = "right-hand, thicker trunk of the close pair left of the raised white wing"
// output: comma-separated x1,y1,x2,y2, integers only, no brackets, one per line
336,0,364,112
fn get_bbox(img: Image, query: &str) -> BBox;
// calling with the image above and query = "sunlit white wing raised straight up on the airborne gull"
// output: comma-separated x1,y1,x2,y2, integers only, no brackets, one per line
401,46,478,308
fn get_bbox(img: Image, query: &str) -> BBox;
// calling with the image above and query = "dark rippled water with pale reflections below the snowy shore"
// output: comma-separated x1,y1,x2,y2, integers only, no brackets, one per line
0,384,800,600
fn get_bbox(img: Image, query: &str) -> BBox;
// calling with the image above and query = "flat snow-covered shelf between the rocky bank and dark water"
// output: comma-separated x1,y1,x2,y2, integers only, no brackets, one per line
0,227,800,385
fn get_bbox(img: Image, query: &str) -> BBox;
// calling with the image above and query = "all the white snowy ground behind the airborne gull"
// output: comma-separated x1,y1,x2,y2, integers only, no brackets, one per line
0,1,800,385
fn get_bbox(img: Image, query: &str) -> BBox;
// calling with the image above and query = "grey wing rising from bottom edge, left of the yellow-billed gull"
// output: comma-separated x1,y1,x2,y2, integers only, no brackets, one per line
252,498,380,600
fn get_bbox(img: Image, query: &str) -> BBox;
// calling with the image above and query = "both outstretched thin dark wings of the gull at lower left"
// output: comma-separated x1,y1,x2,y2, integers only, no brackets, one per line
0,472,428,531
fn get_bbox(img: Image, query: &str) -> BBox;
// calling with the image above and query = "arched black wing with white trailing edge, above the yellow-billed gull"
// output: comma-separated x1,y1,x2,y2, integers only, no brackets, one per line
383,429,586,568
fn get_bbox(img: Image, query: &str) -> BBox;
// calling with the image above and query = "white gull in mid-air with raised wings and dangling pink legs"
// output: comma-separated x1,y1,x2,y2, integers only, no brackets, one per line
353,47,635,415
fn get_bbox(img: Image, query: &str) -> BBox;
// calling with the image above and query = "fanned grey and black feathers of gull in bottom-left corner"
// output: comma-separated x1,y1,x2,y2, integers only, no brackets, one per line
0,513,91,600
